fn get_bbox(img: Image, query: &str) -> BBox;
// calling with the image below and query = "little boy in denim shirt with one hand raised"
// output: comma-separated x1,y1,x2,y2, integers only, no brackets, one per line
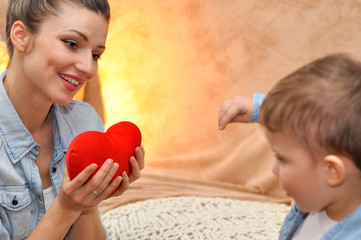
219,54,361,240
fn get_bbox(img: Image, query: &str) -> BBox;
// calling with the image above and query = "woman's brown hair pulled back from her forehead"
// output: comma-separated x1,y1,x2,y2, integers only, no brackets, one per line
6,0,110,58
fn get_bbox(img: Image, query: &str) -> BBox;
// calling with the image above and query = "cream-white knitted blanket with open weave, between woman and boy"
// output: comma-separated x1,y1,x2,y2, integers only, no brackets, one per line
102,197,290,240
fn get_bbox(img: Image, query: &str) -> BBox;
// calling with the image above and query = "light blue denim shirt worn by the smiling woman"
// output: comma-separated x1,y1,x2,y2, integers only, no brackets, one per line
0,71,104,240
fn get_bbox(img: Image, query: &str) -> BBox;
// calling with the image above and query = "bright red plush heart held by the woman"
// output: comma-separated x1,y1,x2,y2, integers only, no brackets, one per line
66,122,142,185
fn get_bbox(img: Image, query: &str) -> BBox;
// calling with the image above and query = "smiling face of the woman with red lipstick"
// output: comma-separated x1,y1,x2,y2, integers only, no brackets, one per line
24,4,108,105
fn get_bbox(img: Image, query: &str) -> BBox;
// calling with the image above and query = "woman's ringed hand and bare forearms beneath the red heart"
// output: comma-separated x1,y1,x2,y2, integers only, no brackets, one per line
28,159,121,240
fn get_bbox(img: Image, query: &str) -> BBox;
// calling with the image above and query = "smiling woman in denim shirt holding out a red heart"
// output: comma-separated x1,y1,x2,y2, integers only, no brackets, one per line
0,0,144,239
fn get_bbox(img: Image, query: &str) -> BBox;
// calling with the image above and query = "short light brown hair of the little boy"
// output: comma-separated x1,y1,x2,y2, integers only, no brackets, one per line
260,54,361,169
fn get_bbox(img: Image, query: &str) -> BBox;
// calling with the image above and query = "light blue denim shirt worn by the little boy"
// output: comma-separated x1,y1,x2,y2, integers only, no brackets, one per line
253,94,361,240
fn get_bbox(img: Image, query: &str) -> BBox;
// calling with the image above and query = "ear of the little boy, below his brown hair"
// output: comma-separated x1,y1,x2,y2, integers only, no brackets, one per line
323,155,346,187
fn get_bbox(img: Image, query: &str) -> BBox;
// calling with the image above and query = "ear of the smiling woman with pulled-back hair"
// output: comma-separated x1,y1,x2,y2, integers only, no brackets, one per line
10,21,30,53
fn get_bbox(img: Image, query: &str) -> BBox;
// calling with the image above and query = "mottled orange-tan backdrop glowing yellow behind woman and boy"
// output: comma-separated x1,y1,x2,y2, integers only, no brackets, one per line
0,0,361,204
